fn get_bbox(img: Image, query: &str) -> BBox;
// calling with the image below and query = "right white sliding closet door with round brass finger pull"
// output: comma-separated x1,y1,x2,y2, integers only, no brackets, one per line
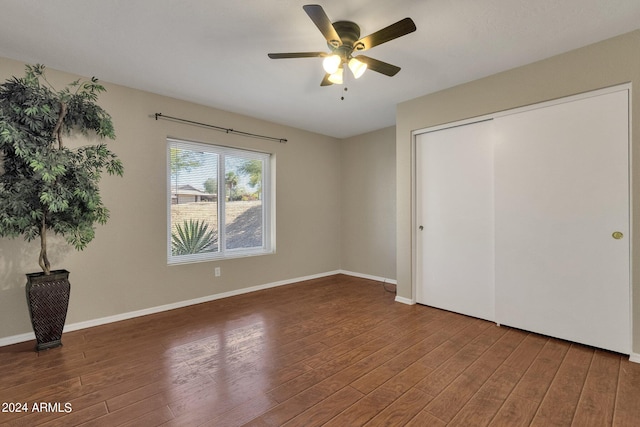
494,90,631,354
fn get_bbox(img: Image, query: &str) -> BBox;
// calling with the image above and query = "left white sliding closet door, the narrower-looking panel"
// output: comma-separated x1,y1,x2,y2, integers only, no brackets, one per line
416,121,494,320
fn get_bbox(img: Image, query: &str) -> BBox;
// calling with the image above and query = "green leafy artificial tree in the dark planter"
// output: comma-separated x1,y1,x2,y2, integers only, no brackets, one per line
0,65,123,345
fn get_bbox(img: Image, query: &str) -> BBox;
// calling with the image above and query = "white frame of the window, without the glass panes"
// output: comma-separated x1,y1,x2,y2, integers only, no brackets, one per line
166,138,275,265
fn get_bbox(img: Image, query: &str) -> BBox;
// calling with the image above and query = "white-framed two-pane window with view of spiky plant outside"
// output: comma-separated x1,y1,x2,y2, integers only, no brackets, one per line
167,139,273,264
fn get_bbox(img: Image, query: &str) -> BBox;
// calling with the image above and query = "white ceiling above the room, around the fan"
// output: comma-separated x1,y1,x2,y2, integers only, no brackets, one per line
0,0,640,138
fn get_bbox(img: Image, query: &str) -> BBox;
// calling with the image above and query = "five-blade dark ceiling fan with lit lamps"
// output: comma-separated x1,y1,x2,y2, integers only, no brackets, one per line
269,4,416,86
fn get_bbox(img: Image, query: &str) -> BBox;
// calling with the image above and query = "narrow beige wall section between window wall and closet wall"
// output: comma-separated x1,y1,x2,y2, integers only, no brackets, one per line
340,127,396,280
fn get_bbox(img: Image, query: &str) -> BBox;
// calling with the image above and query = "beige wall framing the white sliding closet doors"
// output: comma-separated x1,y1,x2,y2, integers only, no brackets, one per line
396,30,640,353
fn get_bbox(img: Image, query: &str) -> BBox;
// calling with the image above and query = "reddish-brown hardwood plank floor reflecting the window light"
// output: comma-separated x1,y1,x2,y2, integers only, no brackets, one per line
0,275,640,427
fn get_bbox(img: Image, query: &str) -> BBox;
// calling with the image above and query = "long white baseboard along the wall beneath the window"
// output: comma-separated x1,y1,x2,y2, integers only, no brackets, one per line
0,270,346,347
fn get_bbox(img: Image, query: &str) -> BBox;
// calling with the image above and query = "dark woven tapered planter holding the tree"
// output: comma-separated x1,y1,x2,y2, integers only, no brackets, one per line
26,270,71,351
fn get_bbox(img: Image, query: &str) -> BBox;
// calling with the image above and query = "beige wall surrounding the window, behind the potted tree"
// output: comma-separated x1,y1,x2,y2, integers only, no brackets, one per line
0,58,344,338
